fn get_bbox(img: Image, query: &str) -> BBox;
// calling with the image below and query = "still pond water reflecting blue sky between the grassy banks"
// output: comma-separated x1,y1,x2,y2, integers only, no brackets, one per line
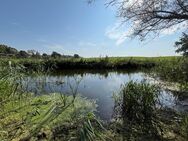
22,72,178,119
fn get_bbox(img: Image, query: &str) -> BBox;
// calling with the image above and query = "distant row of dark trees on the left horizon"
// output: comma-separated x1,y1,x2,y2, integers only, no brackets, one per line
0,44,80,59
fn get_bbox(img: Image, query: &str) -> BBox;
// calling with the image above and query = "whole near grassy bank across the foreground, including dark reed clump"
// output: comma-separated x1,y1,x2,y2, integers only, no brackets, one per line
0,60,188,141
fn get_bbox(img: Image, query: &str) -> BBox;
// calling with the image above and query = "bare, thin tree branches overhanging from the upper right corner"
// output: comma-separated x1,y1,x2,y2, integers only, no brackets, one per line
88,0,188,40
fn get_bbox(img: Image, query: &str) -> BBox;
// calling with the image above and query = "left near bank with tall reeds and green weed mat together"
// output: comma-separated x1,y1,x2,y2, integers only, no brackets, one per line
0,66,104,141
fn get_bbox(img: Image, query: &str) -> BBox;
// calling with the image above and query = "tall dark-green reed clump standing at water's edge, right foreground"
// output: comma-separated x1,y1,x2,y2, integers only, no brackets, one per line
112,81,162,140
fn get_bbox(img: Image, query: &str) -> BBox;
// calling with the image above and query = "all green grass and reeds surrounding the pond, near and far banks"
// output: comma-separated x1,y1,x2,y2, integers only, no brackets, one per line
0,45,188,141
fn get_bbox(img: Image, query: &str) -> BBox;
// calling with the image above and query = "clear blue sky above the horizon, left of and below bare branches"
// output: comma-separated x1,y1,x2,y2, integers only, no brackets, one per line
0,0,182,57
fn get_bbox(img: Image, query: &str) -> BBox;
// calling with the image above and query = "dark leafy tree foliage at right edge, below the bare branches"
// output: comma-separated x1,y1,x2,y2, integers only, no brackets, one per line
175,33,188,56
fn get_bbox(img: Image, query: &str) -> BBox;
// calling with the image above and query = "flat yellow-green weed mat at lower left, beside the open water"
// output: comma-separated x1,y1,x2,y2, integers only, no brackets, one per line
0,94,95,141
